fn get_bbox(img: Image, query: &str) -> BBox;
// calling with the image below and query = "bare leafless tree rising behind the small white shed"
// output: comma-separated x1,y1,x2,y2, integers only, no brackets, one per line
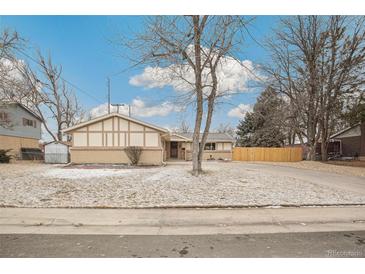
7,53,84,141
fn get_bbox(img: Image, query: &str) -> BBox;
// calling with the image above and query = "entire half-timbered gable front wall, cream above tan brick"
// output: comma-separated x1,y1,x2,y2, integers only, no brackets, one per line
70,117,163,165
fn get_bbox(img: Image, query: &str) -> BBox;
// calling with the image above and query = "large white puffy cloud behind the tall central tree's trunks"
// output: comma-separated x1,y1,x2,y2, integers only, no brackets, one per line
129,53,258,94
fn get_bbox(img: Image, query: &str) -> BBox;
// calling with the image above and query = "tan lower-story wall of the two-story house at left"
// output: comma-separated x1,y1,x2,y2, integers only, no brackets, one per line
0,135,39,157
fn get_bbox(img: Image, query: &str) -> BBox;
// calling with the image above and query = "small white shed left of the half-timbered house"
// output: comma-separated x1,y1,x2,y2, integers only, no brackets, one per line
44,141,70,164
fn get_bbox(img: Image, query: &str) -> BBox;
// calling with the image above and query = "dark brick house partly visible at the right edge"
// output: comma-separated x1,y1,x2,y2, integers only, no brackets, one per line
329,122,365,160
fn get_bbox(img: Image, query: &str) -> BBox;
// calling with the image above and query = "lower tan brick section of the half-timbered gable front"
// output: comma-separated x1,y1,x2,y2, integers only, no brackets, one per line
71,148,162,165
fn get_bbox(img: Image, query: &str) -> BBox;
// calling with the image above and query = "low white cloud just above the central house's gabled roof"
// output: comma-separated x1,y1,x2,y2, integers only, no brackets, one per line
90,98,181,118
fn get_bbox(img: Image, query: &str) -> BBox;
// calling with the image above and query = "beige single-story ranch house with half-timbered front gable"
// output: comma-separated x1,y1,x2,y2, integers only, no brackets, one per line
63,113,233,165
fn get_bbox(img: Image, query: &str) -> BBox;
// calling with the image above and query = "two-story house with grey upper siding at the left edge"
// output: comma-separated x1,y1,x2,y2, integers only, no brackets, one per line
0,102,42,158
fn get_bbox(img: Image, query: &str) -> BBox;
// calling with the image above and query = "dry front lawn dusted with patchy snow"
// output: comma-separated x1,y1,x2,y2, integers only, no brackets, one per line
0,162,365,207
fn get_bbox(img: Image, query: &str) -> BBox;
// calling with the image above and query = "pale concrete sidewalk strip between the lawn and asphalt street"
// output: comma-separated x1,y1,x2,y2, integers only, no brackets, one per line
0,206,365,235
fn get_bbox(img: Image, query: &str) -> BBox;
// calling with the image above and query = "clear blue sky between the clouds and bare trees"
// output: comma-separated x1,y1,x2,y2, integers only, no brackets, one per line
0,16,278,133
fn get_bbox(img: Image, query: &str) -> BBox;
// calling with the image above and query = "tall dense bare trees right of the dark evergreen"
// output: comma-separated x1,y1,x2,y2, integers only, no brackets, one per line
265,16,365,160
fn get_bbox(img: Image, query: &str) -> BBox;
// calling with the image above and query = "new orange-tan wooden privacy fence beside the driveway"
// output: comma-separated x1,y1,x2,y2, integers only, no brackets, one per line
232,147,303,162
